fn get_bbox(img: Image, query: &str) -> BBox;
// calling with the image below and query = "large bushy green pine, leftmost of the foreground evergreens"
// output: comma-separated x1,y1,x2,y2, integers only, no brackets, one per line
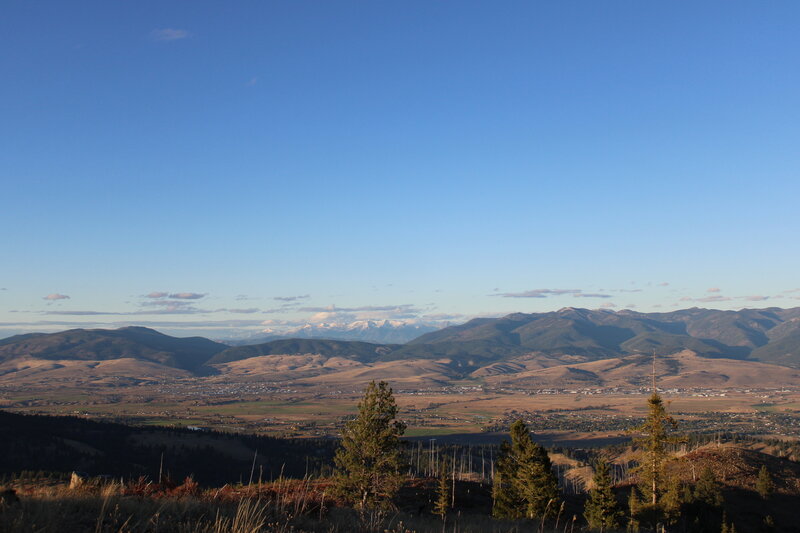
334,381,405,510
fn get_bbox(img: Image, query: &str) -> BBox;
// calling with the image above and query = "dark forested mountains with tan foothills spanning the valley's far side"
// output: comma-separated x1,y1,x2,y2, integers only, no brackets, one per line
0,308,800,386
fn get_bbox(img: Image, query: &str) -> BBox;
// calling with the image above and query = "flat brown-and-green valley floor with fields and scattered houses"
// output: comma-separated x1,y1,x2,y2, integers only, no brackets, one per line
0,379,800,444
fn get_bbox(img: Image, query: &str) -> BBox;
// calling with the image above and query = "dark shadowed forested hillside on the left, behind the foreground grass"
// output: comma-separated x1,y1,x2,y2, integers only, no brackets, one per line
0,411,335,485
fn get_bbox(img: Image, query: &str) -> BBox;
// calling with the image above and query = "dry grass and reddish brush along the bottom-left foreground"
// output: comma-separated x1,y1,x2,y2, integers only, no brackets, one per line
0,479,578,533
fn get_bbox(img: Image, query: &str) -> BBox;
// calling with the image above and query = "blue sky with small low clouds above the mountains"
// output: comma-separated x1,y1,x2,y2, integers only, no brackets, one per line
0,0,800,336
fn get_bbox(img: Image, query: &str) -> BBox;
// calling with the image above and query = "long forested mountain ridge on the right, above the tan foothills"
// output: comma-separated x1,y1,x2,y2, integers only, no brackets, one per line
410,307,800,367
